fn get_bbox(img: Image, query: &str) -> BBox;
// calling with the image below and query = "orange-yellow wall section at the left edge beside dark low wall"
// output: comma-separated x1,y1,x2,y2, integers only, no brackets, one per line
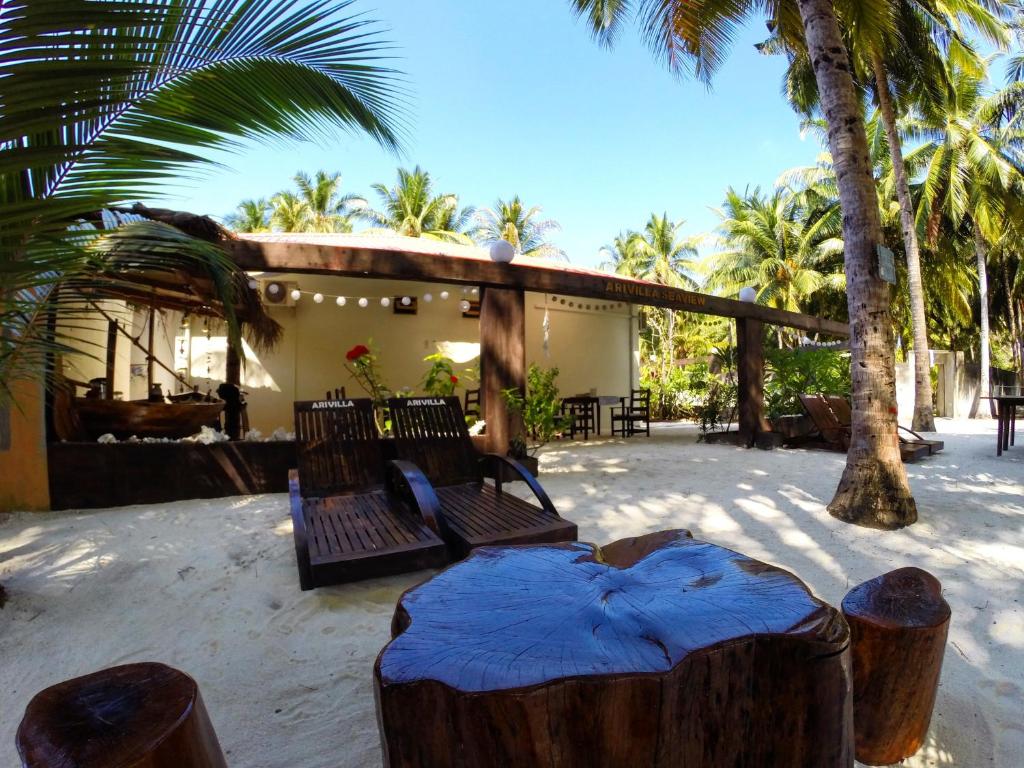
0,382,50,512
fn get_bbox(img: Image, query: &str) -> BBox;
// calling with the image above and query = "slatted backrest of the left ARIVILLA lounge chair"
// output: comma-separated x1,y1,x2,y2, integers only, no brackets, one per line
295,398,384,498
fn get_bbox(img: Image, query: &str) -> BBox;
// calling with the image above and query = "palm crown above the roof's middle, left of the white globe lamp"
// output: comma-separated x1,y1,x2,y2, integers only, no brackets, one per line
358,166,473,244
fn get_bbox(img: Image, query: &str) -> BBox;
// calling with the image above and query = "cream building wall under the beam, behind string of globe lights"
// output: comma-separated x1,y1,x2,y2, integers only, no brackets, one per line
180,274,634,435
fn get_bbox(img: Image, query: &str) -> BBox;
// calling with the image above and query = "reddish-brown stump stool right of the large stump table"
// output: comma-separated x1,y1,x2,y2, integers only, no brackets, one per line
843,568,950,765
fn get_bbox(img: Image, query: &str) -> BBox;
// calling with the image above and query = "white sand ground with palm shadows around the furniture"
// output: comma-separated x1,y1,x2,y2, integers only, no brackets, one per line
0,421,1024,768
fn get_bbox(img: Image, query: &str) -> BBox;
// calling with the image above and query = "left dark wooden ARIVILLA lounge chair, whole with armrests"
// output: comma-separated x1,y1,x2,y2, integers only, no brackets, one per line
288,399,449,590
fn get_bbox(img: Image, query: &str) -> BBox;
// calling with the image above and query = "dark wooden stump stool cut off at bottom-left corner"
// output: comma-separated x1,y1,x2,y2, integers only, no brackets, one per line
17,663,226,768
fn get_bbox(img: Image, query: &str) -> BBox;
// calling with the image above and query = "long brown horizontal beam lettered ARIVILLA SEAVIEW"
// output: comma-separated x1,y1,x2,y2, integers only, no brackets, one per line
226,239,850,337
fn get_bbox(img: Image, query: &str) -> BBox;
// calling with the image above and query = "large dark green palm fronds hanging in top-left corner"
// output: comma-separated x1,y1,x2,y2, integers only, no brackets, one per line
0,0,401,396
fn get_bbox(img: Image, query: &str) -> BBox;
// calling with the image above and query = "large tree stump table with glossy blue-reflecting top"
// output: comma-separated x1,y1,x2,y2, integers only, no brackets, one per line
374,530,853,768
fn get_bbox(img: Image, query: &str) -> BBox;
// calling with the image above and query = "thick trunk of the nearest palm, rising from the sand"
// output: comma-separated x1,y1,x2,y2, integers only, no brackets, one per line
798,0,918,529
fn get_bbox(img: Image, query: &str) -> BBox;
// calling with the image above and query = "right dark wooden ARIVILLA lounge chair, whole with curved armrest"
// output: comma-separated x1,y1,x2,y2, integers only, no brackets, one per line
388,397,577,557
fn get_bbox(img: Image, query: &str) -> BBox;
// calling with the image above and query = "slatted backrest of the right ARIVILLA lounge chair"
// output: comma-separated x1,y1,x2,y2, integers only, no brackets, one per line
388,397,480,486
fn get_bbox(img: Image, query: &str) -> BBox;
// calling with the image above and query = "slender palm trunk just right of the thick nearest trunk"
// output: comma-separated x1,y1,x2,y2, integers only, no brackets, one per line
871,50,935,432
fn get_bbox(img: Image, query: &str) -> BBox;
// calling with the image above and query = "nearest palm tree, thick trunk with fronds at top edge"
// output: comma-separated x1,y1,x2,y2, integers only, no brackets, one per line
570,0,918,528
